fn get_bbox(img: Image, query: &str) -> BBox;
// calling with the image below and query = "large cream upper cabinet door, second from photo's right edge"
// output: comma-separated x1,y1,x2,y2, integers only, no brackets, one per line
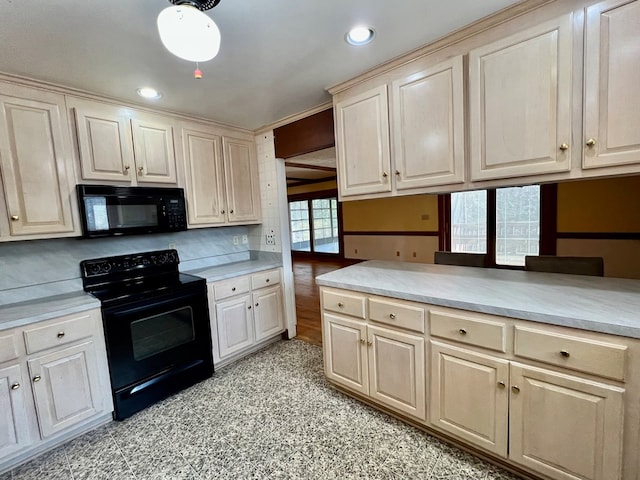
469,14,581,181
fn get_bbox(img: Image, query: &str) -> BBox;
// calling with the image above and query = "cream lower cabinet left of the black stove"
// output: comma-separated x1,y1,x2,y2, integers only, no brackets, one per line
0,309,113,465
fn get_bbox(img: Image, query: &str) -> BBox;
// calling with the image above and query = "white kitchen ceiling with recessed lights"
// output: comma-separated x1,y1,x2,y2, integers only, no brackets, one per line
0,0,519,130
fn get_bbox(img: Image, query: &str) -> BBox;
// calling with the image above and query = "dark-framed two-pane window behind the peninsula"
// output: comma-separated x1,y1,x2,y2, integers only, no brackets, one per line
445,185,542,266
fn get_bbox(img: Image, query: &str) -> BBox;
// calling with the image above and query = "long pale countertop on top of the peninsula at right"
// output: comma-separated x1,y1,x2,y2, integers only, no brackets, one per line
316,260,640,338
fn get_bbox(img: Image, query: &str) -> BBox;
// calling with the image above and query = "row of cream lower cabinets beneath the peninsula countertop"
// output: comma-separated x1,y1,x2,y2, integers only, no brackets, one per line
321,287,640,480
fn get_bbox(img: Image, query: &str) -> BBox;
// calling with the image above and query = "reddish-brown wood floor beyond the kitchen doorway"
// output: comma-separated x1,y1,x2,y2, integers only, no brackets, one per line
293,256,359,345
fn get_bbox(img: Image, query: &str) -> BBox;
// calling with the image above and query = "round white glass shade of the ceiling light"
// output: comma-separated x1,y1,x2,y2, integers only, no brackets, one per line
158,5,220,62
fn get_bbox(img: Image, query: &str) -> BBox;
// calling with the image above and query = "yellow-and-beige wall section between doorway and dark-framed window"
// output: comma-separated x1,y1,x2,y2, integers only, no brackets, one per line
342,195,438,263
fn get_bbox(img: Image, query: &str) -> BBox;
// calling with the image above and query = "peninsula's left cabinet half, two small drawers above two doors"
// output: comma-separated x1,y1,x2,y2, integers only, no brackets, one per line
322,289,426,421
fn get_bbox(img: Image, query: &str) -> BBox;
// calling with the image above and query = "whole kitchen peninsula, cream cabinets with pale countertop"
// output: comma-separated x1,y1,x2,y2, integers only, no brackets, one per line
316,261,640,480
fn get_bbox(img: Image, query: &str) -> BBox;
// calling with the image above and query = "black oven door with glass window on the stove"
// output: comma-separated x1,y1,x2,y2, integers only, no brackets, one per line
103,285,213,394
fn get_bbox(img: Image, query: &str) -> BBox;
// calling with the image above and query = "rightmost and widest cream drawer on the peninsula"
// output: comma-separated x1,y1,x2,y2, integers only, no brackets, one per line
514,327,627,380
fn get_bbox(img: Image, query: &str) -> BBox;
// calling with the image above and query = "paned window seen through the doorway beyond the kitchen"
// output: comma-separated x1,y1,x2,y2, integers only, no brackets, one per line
289,197,340,254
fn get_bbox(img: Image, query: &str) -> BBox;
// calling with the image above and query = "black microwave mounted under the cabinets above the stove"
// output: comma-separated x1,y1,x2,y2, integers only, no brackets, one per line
77,185,187,238
